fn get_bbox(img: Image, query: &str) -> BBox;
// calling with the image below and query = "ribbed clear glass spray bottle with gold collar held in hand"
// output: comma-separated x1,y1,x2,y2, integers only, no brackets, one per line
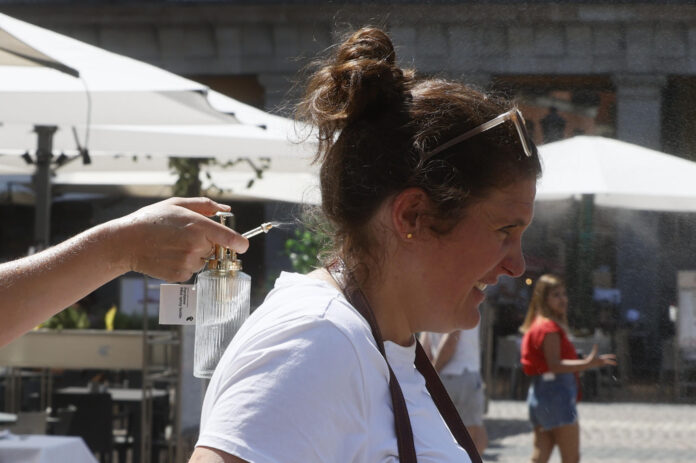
193,212,251,378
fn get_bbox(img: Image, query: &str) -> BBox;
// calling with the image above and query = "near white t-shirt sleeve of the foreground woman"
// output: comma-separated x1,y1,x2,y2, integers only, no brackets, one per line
197,318,368,463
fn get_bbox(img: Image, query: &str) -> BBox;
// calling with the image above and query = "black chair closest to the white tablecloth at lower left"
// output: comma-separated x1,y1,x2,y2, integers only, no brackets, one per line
53,392,113,462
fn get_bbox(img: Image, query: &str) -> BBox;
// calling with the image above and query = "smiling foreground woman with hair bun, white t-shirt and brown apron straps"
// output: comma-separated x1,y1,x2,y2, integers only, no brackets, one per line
191,27,541,463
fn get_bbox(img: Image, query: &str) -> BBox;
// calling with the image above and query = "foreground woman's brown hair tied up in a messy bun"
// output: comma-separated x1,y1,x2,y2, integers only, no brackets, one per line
297,27,541,280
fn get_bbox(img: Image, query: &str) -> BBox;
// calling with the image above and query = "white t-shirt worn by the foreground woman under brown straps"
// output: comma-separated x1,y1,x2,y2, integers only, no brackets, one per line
197,273,471,463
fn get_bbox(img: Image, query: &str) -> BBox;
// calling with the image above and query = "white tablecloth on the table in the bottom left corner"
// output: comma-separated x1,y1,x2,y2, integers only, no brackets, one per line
0,434,97,463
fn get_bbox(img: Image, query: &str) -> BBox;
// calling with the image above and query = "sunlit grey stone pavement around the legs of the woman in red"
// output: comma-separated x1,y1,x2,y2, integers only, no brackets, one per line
483,400,696,463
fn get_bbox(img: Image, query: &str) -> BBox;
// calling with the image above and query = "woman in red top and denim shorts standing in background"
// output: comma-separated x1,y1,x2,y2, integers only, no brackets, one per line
520,274,616,463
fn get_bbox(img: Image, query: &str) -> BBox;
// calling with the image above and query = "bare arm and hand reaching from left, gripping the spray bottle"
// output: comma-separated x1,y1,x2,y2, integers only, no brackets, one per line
0,198,249,346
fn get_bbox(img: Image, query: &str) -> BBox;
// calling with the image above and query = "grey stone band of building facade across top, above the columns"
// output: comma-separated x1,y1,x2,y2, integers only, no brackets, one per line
3,2,696,116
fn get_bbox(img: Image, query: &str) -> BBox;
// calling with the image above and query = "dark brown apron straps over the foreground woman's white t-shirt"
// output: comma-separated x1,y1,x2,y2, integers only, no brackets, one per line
326,263,481,463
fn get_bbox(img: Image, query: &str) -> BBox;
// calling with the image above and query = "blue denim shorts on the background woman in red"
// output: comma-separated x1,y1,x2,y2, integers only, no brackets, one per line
527,373,578,431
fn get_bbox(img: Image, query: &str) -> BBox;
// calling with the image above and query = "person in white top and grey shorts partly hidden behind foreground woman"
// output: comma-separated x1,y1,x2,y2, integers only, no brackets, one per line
421,325,488,454
